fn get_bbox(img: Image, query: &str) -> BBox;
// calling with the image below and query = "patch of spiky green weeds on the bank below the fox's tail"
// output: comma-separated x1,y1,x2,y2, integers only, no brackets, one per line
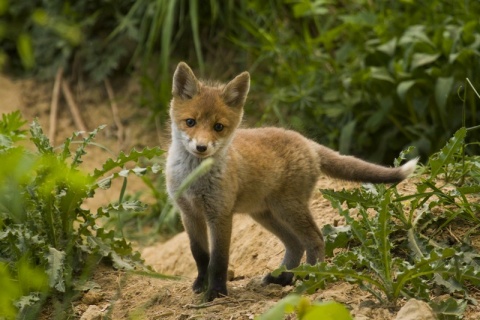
276,128,480,318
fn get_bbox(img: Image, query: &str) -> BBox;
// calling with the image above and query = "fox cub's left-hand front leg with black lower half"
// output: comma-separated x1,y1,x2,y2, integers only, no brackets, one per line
179,201,210,293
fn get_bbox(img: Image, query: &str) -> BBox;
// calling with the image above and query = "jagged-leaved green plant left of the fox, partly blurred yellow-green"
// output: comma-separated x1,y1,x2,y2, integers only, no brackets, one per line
0,112,163,312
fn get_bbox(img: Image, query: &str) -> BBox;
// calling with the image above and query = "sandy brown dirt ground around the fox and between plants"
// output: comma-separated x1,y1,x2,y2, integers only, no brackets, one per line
0,76,480,320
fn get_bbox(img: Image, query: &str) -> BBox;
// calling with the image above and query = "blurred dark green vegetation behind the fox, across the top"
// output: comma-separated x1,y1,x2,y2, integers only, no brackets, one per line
0,0,480,164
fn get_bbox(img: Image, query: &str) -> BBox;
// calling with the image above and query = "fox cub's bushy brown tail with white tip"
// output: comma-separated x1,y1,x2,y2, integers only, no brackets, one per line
318,145,418,183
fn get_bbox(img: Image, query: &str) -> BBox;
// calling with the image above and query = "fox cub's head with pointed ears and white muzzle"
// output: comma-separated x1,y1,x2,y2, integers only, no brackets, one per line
170,62,250,158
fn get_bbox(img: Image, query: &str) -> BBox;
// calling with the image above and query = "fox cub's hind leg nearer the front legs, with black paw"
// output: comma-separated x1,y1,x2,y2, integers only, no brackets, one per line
252,210,305,286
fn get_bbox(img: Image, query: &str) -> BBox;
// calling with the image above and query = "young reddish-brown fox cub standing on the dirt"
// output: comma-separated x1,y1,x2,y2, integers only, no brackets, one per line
165,62,418,301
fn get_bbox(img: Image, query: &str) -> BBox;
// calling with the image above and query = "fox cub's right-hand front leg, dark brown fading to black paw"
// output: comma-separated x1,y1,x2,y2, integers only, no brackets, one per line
205,215,232,301
